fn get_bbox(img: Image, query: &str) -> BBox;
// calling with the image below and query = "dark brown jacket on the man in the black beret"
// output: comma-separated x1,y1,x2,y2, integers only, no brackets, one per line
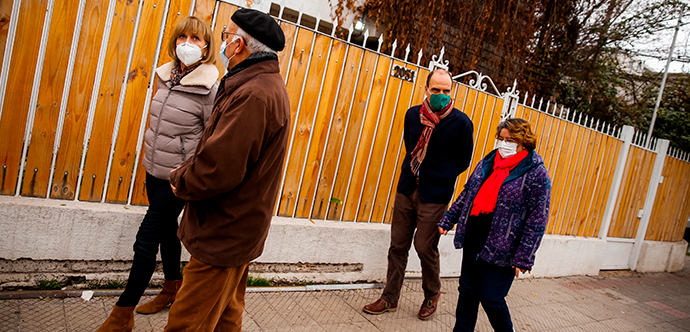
170,53,290,267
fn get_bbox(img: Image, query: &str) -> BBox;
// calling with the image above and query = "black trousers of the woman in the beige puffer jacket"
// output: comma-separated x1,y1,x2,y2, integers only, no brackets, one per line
117,173,185,307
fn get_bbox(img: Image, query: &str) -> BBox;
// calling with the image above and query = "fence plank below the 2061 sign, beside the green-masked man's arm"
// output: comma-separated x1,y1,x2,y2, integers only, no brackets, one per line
371,64,418,222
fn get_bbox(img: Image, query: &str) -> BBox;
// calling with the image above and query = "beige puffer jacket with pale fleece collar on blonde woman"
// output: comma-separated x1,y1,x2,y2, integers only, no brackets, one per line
144,61,218,180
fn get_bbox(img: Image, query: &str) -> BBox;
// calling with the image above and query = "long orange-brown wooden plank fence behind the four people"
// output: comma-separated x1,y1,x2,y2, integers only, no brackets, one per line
0,0,690,241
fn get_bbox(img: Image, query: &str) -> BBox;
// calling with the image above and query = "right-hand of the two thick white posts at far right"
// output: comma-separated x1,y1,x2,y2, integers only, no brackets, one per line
628,139,669,270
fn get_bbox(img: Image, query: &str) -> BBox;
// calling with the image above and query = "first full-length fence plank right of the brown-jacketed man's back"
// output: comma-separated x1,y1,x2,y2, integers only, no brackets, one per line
278,29,320,216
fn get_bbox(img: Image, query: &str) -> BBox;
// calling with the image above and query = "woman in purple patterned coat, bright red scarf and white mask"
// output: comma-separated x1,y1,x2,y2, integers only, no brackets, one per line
438,118,551,331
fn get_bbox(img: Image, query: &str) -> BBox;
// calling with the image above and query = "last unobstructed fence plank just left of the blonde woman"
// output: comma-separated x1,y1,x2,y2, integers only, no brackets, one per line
106,0,165,203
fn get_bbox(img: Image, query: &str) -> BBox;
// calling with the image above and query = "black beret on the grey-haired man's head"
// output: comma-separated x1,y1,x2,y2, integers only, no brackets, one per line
231,8,285,52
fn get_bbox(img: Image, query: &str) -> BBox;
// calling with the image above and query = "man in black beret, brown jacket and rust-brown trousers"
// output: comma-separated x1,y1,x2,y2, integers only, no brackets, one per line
165,9,290,331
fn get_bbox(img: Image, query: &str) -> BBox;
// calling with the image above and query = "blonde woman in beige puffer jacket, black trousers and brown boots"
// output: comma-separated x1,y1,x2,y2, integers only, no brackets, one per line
98,16,218,332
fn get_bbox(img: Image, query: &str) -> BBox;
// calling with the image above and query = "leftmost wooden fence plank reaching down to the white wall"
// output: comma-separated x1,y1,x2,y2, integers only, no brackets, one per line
0,0,48,195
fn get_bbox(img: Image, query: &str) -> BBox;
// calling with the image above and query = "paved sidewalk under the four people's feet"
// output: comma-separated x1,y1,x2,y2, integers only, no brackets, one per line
0,256,690,332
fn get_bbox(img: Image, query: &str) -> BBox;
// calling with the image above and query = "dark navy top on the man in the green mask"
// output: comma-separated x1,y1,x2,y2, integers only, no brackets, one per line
398,105,474,204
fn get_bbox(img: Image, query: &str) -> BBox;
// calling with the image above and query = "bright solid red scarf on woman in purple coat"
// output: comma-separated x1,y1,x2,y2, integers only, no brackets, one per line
470,150,529,216
